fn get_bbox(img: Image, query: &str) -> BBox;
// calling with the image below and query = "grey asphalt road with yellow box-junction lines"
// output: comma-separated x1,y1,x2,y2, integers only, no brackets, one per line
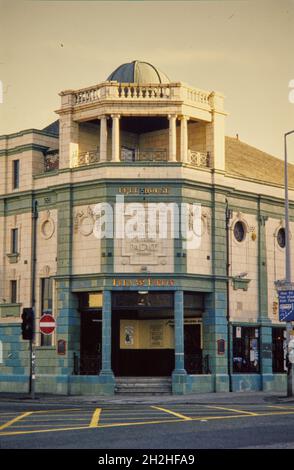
0,402,294,449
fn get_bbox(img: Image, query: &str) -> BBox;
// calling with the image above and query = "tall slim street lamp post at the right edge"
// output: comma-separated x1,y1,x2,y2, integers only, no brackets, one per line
284,130,294,397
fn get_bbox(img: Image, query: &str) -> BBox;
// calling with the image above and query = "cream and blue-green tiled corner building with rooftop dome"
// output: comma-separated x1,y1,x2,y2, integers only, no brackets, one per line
0,61,294,395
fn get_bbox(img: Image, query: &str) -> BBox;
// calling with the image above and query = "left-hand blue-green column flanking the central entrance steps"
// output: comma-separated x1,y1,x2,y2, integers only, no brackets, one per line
99,290,115,393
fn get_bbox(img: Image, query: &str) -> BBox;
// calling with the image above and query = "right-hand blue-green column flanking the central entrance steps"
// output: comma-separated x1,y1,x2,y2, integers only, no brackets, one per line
172,290,187,395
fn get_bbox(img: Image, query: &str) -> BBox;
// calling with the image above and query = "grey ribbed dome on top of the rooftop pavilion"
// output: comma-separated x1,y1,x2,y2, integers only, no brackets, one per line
107,60,170,84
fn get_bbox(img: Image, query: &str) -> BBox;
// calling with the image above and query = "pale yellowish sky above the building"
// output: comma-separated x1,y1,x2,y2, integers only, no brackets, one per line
0,0,294,163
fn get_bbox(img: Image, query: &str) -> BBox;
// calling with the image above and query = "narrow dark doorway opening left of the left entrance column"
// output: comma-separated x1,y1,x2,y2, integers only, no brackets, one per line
80,310,102,375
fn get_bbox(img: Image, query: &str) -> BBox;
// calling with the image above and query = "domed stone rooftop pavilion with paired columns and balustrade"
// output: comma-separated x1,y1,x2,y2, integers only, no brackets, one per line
57,61,226,170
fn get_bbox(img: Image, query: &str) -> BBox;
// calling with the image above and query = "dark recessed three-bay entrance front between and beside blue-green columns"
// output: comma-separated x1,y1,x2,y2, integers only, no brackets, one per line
79,291,208,377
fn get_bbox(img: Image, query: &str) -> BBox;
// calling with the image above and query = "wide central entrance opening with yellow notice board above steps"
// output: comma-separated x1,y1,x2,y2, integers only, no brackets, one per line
112,291,175,377
